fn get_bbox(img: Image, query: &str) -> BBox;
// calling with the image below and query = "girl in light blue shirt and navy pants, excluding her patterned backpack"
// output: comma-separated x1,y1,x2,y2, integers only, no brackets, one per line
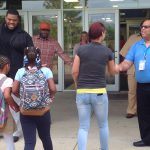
13,47,56,150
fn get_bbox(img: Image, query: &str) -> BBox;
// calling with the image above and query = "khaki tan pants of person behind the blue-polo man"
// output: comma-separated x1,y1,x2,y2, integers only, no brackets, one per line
127,74,137,114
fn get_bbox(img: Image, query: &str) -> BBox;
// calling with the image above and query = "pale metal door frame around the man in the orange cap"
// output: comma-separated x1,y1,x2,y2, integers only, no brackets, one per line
0,10,64,91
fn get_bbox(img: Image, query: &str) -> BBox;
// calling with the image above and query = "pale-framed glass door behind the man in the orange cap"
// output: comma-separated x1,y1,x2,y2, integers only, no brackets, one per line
29,11,63,91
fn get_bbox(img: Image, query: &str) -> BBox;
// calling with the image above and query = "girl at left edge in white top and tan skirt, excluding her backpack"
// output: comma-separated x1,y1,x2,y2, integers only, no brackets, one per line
0,55,19,150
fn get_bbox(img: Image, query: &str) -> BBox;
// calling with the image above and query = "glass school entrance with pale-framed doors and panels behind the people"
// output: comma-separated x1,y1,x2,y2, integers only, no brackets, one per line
0,10,119,91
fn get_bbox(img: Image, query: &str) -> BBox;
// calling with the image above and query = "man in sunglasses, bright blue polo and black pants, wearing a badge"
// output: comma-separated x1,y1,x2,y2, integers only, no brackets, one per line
116,19,150,147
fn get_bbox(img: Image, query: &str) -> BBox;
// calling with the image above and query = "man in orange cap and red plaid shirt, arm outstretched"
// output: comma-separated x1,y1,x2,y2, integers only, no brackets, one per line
32,22,72,69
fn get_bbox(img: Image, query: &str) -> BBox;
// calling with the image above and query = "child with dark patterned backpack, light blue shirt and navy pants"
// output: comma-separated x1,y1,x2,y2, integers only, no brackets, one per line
13,47,56,150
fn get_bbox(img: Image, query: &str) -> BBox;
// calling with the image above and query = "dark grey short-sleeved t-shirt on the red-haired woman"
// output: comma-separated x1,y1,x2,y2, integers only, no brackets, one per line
77,42,114,89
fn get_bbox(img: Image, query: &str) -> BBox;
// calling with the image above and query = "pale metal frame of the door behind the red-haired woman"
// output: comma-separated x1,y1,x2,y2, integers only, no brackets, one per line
85,9,120,91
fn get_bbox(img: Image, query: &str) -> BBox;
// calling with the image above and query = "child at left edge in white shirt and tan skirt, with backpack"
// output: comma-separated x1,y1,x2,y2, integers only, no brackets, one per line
0,55,19,150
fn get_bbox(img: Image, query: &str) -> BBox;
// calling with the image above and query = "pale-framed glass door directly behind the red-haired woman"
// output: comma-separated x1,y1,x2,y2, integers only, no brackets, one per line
85,10,119,91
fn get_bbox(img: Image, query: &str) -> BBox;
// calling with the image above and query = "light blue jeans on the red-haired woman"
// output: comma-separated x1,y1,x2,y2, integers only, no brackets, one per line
76,93,109,150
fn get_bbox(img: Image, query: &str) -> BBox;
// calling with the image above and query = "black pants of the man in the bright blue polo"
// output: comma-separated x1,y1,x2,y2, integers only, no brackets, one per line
137,83,150,145
